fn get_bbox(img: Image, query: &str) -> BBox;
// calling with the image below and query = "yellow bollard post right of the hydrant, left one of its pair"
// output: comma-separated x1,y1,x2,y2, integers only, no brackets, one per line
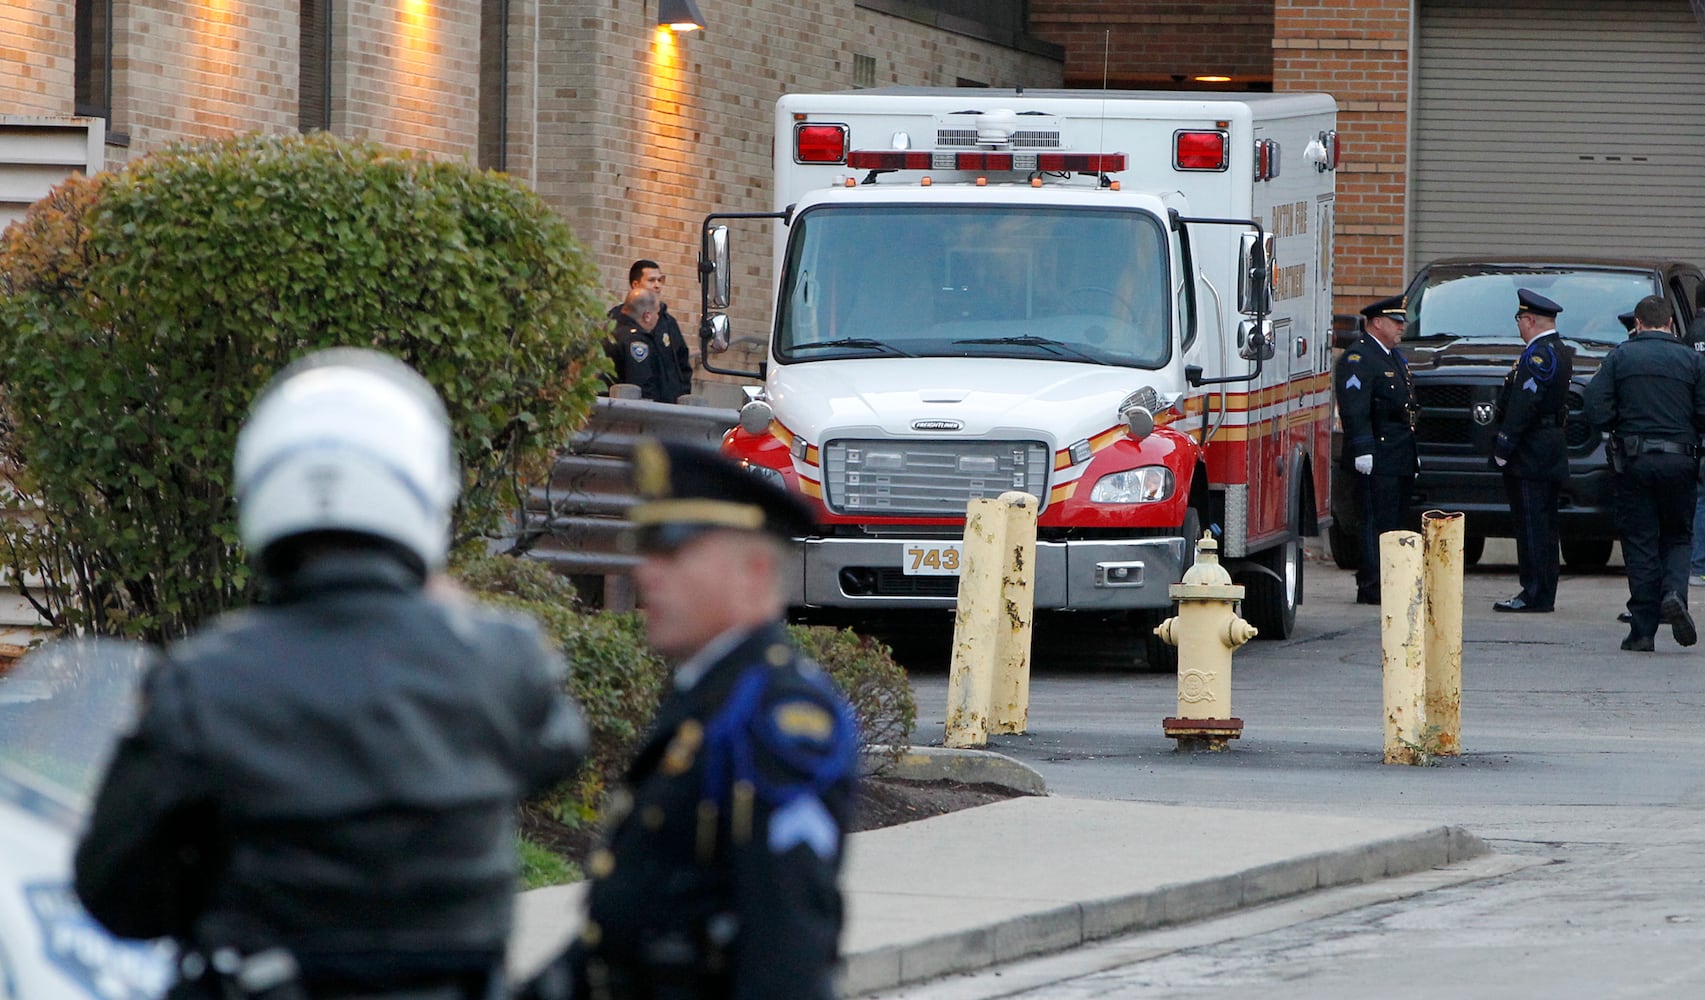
1379,532,1427,763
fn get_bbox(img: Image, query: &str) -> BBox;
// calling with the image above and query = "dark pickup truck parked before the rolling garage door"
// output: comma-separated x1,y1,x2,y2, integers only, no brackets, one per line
1330,257,1705,569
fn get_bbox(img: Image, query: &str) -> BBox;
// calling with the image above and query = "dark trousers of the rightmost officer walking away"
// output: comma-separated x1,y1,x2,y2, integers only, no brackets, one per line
1616,455,1698,635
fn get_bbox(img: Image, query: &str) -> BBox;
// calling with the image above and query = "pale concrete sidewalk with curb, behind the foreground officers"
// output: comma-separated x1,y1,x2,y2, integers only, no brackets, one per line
510,796,1487,997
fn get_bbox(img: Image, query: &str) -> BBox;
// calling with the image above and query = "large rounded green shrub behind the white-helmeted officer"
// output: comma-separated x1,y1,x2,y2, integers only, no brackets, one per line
0,133,607,641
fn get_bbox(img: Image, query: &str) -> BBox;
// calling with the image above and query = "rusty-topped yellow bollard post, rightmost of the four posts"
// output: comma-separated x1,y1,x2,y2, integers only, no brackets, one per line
1420,511,1463,756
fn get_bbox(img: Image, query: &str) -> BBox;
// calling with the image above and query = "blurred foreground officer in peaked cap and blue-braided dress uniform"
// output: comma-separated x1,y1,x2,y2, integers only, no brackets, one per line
523,441,858,1000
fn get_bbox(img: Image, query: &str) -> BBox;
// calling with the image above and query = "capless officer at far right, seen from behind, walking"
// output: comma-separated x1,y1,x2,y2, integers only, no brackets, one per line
1586,295,1705,652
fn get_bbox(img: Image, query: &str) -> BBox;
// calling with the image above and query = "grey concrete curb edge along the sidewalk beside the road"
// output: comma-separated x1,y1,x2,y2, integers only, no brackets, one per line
842,826,1490,997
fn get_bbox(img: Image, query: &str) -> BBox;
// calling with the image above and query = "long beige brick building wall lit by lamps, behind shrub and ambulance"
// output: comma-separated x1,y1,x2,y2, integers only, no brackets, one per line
0,0,1064,403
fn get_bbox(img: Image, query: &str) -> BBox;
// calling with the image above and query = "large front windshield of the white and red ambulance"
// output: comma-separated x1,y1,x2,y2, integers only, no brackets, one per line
776,204,1171,368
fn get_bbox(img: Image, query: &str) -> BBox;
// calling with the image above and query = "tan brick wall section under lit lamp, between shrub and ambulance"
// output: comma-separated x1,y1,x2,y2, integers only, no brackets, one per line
537,0,1061,405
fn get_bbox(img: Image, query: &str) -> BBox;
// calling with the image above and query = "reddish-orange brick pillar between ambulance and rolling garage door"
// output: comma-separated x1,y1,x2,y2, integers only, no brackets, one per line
1274,0,1410,312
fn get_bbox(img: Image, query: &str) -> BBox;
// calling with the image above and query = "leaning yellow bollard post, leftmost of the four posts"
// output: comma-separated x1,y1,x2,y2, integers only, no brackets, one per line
943,497,1006,748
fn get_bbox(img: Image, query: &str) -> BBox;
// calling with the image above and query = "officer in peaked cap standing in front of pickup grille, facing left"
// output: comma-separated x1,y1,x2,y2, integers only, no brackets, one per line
1492,288,1574,612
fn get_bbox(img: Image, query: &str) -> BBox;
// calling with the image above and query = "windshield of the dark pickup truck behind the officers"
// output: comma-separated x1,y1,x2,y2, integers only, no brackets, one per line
1403,266,1662,344
